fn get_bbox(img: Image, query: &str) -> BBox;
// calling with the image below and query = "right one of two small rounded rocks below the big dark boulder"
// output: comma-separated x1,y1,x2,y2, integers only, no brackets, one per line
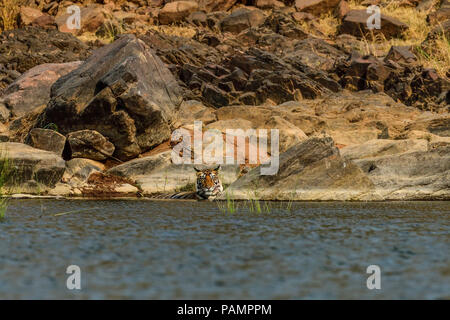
67,130,115,161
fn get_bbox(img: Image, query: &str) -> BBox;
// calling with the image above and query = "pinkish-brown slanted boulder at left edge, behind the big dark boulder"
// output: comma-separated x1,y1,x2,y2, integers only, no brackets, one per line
0,61,82,117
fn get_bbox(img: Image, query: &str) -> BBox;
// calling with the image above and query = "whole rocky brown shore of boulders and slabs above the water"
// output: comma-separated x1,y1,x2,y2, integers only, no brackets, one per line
0,0,450,201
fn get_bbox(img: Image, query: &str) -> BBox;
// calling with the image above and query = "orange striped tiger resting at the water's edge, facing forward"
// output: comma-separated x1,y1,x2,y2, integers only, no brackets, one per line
157,165,223,200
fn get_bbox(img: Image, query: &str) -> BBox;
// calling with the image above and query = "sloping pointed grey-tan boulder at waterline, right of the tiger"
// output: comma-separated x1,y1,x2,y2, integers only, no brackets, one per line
223,136,373,200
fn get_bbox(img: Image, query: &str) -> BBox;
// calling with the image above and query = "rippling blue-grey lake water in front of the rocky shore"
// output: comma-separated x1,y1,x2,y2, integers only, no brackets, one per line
0,199,450,299
